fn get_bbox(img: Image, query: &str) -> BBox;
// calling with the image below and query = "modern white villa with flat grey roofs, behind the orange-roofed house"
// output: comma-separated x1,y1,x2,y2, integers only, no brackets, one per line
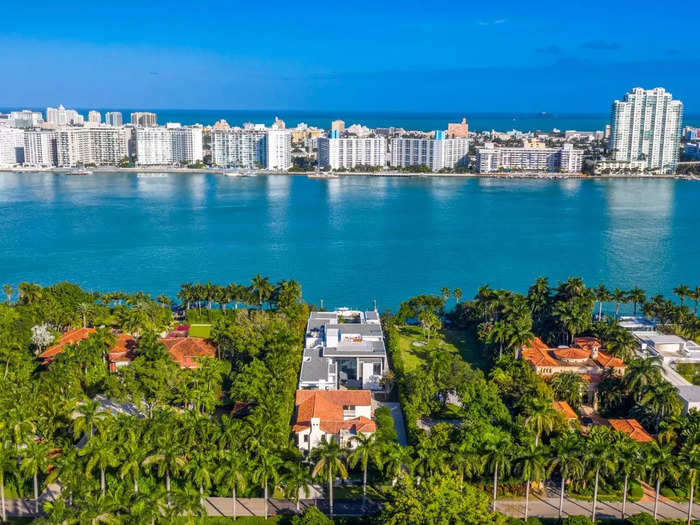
299,309,388,390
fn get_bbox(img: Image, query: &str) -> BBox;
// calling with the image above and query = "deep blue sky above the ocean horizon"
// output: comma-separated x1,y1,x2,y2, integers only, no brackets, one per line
0,0,700,114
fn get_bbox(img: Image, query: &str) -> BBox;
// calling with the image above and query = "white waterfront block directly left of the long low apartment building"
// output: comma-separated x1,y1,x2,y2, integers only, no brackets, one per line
390,132,469,171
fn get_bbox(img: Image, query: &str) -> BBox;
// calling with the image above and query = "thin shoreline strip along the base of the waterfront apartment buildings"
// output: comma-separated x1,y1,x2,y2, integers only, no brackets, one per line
0,166,700,180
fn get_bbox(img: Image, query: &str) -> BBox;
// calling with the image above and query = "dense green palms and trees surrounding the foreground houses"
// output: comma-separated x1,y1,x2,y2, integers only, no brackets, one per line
0,275,700,524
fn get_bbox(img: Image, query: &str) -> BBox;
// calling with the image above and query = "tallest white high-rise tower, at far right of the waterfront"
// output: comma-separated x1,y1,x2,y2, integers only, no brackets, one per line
610,88,683,173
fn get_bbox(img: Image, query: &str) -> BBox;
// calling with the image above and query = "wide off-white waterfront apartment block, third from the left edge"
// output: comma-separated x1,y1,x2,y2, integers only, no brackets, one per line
56,127,131,167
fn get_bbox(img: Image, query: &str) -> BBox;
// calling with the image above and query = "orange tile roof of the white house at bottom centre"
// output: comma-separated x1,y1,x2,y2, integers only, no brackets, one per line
293,390,377,434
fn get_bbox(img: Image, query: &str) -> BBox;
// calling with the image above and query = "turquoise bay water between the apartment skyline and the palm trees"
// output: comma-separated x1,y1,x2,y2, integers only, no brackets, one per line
0,173,700,309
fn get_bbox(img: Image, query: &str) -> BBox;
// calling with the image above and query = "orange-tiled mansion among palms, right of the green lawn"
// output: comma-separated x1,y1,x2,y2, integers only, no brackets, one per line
518,337,625,406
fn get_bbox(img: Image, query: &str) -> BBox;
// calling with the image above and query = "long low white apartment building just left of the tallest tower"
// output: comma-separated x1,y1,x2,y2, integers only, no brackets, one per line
476,143,583,173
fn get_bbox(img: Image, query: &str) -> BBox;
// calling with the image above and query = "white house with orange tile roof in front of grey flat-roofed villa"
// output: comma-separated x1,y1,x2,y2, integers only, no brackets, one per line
293,390,377,452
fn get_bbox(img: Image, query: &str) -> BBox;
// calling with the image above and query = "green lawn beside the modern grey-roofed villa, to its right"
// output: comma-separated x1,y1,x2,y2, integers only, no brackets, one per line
399,326,488,372
